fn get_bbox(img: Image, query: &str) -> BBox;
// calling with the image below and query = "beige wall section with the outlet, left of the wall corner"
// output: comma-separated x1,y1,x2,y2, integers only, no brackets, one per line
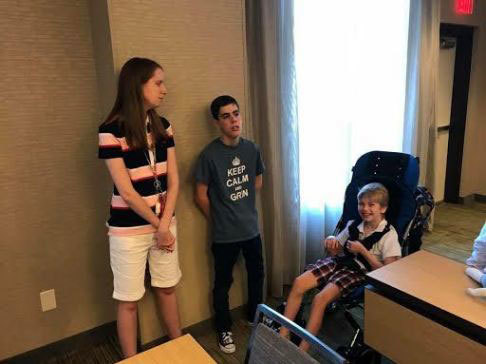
0,0,114,359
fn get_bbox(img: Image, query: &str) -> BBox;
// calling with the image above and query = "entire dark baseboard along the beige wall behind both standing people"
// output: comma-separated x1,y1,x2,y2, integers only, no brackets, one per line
0,305,246,364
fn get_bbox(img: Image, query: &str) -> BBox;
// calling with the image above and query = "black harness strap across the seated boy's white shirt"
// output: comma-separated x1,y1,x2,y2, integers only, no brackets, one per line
336,219,391,272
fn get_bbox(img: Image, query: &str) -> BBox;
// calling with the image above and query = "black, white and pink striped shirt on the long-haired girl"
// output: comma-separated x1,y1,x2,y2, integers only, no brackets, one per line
98,118,175,236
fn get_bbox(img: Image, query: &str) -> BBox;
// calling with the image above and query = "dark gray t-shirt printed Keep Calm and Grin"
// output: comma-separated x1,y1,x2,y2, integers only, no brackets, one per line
196,138,265,243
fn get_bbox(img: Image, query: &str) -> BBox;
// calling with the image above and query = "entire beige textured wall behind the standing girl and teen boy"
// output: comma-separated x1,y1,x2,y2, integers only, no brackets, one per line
0,0,246,360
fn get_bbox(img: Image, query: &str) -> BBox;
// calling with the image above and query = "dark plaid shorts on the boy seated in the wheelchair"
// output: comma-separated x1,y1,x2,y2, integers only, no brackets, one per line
305,257,366,297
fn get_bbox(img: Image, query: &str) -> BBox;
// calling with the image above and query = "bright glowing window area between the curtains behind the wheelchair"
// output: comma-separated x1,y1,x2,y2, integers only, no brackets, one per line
294,0,410,261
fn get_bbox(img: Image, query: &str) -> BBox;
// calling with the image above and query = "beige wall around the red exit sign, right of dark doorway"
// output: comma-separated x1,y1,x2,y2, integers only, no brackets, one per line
441,0,486,196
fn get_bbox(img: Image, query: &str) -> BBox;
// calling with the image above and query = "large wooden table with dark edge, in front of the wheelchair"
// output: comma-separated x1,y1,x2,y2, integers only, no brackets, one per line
364,251,486,364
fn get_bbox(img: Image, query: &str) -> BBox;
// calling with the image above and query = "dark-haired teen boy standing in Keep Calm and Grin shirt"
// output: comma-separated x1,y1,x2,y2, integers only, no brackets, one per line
195,96,265,353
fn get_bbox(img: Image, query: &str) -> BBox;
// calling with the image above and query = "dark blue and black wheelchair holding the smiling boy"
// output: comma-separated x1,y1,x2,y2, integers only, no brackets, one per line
279,151,434,363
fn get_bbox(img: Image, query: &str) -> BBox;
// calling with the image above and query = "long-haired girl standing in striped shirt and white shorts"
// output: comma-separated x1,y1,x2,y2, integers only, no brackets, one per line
99,58,181,357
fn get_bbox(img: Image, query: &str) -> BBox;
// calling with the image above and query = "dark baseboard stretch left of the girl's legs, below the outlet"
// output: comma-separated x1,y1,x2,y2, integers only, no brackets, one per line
0,321,116,364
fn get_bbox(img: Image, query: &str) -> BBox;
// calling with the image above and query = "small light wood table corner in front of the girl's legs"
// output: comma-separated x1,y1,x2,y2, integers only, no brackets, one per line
118,334,216,364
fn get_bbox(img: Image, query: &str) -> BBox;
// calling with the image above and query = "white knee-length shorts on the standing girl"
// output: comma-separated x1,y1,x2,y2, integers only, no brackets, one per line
109,218,182,302
